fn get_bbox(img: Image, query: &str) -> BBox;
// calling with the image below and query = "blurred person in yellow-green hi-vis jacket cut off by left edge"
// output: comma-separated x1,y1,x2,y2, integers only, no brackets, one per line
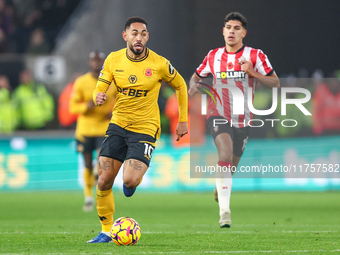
0,75,18,133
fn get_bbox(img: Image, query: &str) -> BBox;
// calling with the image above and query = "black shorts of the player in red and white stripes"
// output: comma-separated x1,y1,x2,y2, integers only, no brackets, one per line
207,116,249,157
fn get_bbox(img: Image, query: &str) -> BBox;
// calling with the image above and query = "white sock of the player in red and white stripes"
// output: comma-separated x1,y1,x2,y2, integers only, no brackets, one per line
216,172,233,216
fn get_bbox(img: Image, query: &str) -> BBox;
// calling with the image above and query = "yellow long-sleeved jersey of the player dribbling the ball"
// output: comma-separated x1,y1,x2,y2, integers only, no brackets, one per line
93,48,188,139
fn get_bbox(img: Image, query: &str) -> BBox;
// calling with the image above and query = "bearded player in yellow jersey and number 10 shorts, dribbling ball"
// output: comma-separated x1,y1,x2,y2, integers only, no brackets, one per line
88,17,188,243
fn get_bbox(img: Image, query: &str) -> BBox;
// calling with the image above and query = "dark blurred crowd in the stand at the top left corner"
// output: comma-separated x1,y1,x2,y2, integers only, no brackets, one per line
0,0,80,54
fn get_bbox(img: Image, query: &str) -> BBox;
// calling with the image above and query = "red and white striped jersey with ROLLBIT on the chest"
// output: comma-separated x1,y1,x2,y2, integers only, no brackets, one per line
196,46,273,128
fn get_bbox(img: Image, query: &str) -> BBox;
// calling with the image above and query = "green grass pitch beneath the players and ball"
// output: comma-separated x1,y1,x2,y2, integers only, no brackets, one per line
0,190,340,254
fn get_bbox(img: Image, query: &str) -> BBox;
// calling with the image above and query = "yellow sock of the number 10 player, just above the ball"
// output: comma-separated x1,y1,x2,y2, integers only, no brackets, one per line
96,187,115,232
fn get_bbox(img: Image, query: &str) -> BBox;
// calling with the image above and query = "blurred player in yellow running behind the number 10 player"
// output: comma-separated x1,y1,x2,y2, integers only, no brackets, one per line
70,51,115,211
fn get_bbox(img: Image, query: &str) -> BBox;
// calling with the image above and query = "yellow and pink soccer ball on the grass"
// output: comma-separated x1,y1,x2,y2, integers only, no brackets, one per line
110,217,142,245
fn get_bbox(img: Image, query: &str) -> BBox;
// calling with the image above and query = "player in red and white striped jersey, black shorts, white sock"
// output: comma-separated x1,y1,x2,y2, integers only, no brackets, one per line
189,12,280,228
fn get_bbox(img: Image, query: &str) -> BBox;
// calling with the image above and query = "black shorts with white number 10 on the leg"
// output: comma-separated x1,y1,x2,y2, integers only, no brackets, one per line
99,123,156,166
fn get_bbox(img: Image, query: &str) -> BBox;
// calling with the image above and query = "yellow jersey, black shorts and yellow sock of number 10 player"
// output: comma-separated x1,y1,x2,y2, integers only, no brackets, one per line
93,48,188,232
